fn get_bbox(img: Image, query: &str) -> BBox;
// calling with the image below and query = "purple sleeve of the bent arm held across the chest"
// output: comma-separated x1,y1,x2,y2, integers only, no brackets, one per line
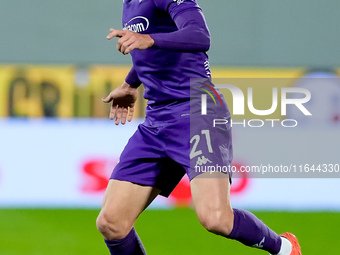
150,5,210,52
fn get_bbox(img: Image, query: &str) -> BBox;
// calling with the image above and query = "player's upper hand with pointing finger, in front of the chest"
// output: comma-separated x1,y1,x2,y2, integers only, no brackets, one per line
106,28,155,55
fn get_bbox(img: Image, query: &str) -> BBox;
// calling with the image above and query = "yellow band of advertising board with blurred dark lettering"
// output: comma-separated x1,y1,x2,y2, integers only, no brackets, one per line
0,65,340,119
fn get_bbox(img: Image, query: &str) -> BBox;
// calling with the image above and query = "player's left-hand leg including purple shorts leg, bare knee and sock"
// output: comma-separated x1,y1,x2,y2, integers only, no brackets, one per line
97,124,165,254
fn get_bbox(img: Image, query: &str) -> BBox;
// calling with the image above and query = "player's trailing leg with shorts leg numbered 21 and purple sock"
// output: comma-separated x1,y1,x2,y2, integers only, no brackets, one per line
187,80,296,255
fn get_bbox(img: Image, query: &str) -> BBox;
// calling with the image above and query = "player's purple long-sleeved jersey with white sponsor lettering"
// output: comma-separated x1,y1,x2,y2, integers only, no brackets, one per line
123,0,210,107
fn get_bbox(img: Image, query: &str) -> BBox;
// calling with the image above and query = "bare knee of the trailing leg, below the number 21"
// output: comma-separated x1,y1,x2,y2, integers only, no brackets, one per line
198,210,234,237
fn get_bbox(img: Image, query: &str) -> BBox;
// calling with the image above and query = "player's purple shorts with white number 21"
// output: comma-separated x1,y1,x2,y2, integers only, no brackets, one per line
111,81,232,197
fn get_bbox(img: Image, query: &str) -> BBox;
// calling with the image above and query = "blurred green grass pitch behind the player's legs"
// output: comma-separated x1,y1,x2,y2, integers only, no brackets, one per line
0,209,340,255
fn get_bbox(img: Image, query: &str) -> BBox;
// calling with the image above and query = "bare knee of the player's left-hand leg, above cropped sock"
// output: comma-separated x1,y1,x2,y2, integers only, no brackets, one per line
96,211,133,240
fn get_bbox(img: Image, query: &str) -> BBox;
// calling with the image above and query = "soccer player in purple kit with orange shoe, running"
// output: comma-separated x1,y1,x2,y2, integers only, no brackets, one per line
97,0,301,255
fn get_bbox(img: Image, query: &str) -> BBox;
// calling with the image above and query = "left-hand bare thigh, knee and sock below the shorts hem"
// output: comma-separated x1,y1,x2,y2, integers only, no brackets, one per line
97,179,160,255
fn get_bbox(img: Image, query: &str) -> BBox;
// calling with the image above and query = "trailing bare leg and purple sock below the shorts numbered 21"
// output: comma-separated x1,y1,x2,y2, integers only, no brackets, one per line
190,173,291,255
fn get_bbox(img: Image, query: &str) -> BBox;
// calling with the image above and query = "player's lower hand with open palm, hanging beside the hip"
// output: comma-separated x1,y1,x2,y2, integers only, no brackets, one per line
102,82,138,125
